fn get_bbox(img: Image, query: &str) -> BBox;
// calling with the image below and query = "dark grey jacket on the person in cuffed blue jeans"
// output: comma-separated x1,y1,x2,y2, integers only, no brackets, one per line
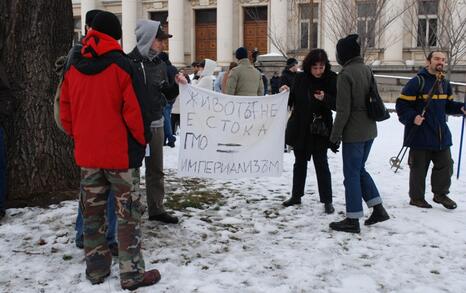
330,57,377,143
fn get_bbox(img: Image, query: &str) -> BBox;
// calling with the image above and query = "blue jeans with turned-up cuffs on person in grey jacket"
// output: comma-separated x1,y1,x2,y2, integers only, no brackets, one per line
343,139,382,219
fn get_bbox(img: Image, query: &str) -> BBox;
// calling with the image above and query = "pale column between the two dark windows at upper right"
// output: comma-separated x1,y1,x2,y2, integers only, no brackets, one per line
383,0,404,65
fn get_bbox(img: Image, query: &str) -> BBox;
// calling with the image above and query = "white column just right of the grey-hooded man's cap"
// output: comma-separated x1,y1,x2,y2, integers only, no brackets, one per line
168,0,185,67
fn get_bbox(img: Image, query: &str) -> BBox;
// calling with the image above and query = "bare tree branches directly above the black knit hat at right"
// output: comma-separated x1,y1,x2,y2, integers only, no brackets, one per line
324,0,406,60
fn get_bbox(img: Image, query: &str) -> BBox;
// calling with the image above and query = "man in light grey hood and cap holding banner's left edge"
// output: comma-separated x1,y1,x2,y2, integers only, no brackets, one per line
128,20,179,224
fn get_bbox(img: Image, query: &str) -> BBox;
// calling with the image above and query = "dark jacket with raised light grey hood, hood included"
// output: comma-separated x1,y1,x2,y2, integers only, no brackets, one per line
128,20,178,122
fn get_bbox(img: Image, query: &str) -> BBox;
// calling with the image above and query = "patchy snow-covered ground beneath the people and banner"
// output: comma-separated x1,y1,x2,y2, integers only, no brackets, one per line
0,113,466,293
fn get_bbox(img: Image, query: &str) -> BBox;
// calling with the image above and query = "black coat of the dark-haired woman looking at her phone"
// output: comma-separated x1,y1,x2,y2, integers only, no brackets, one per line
287,68,337,158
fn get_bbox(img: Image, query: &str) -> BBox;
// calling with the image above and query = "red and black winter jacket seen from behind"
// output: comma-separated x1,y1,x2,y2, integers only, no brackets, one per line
60,29,150,170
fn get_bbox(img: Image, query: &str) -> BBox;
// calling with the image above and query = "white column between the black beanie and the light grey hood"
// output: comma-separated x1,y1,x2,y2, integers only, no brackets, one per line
121,0,138,53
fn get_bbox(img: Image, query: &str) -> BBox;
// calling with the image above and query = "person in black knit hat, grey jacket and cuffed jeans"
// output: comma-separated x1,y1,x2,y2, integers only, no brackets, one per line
330,34,390,233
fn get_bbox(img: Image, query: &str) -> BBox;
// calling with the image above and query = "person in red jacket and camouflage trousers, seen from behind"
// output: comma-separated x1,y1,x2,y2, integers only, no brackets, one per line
60,12,160,290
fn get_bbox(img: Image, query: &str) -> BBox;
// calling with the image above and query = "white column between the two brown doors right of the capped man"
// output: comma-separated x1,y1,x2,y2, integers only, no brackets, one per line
217,0,233,66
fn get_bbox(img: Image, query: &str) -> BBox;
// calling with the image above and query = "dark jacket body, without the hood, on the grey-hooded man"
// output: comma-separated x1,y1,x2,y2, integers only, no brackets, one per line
128,47,169,121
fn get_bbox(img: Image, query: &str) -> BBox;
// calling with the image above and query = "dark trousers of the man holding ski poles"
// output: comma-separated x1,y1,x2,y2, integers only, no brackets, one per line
408,148,453,199
